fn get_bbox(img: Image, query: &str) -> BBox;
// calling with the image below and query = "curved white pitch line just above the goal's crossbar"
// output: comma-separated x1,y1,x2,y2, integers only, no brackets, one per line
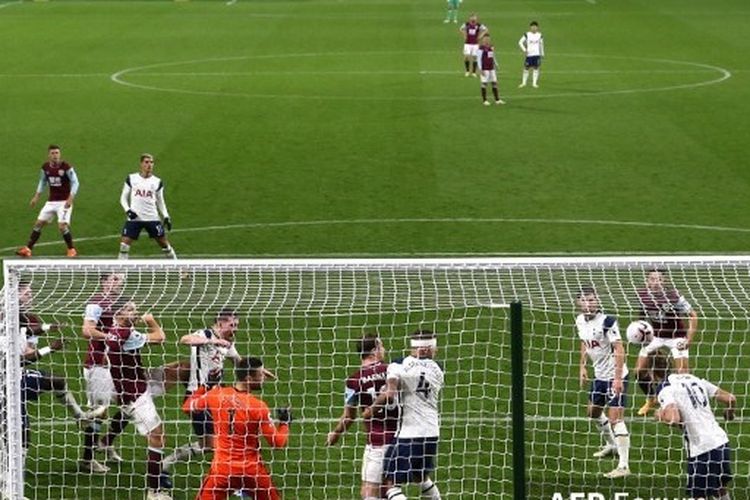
0,217,750,255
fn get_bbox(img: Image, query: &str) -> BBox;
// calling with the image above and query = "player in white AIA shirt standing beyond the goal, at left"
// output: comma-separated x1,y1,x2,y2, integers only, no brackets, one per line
119,153,177,259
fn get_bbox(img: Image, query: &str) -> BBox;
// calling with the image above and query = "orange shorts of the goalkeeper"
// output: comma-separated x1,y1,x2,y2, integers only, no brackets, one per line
196,463,281,500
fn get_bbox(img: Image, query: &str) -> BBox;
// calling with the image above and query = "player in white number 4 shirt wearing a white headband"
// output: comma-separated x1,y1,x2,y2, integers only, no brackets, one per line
362,330,445,500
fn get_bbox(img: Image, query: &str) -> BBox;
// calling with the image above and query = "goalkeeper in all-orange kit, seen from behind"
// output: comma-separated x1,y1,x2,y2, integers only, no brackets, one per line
182,358,292,500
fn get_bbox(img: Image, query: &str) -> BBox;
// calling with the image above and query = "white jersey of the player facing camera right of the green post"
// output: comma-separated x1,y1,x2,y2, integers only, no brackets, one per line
576,312,628,380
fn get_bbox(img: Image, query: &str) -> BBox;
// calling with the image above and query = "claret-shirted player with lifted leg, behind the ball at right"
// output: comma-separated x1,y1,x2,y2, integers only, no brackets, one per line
635,269,698,415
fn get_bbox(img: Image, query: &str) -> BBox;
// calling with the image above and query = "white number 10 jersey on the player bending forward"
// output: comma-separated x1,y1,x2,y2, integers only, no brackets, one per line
659,373,729,457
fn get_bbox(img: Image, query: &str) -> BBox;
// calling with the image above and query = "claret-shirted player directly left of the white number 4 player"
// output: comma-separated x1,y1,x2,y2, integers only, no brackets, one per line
326,335,399,500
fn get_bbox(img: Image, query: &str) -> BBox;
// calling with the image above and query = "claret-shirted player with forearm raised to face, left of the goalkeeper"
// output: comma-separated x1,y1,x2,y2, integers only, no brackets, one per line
107,302,171,500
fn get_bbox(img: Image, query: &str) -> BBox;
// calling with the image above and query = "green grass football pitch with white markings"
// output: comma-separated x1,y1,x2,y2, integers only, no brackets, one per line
0,0,750,499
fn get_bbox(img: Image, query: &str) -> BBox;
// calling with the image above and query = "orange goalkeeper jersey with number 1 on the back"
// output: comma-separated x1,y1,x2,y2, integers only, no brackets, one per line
182,387,289,466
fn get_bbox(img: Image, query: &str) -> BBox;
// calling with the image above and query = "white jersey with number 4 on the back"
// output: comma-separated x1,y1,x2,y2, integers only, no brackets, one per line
387,356,444,438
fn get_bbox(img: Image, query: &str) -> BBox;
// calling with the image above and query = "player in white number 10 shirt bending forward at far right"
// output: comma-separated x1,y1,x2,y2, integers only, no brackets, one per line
656,373,737,500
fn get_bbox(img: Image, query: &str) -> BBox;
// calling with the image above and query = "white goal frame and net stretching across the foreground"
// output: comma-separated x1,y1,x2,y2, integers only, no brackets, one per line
0,256,750,500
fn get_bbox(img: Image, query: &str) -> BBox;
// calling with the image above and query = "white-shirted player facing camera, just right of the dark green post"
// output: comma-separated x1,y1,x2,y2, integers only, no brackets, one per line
576,287,630,478
